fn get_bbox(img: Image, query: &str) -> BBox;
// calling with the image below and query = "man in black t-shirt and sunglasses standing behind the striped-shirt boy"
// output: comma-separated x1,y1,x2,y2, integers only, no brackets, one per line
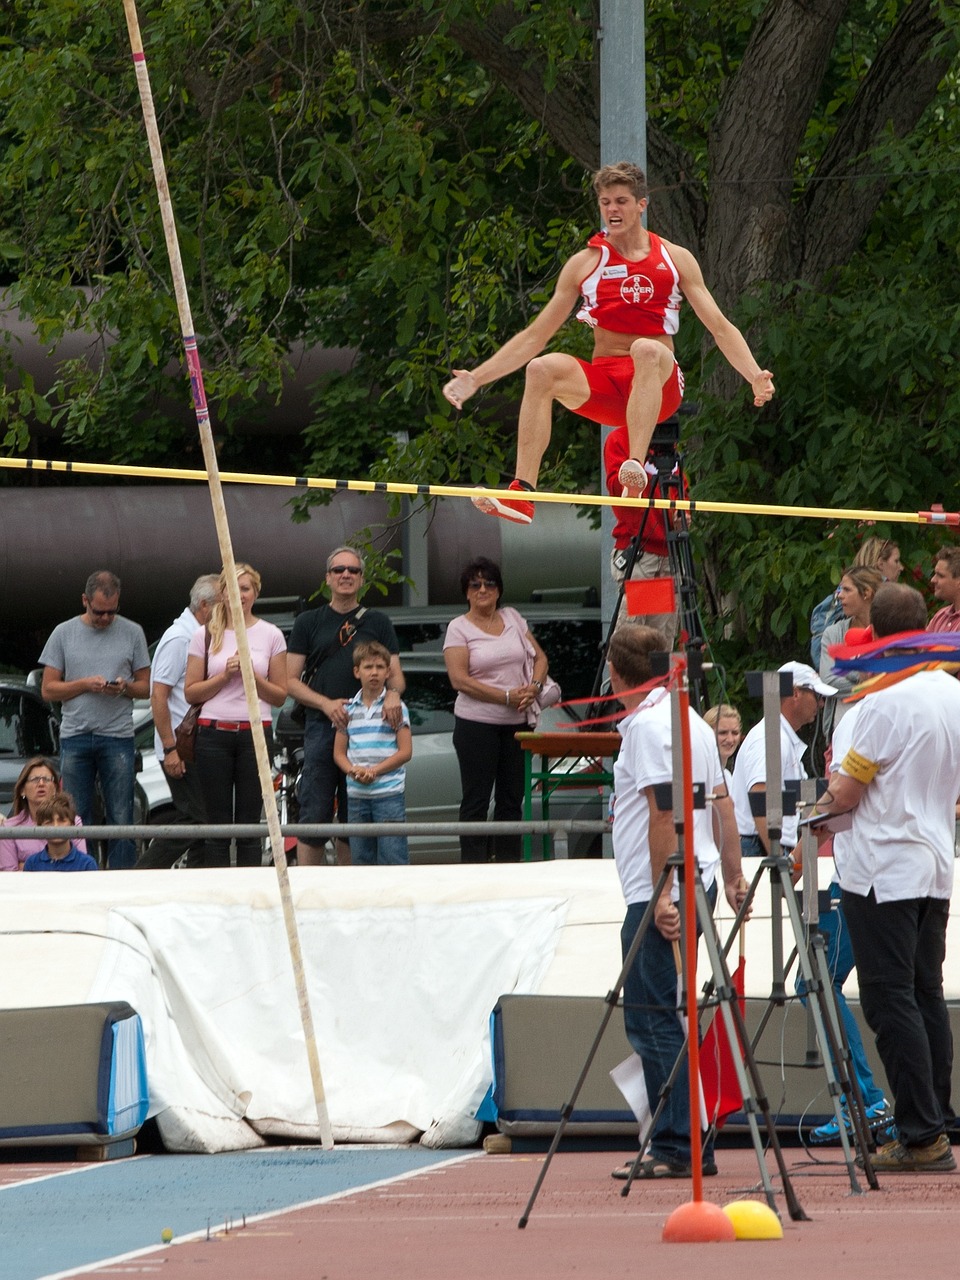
287,547,406,867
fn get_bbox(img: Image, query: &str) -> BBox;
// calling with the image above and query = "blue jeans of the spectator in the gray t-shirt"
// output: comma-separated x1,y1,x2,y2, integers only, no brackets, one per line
60,733,137,872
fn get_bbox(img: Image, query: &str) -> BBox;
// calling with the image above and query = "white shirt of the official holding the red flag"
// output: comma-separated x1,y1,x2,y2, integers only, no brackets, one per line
613,689,726,905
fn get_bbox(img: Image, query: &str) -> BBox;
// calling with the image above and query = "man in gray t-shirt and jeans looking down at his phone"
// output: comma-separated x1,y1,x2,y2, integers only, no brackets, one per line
40,570,150,870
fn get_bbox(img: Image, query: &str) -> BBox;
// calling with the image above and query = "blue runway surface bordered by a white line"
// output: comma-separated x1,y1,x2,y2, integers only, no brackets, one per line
0,1147,462,1280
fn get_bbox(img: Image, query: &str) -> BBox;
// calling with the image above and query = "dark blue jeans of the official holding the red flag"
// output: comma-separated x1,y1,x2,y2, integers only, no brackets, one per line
620,884,717,1165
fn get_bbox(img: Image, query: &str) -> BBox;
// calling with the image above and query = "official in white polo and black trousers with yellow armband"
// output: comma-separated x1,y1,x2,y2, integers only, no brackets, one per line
817,582,960,1172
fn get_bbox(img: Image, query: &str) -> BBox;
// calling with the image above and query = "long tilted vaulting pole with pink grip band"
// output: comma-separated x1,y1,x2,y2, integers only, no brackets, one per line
123,0,333,1148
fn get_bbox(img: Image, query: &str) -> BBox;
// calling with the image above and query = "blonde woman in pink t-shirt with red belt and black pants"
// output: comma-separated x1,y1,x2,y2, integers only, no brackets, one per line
183,563,287,867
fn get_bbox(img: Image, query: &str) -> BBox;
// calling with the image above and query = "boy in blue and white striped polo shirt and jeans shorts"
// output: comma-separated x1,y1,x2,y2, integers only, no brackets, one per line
333,640,413,867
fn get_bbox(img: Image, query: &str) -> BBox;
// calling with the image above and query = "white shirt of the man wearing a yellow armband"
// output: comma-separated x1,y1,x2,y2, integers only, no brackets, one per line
833,671,960,902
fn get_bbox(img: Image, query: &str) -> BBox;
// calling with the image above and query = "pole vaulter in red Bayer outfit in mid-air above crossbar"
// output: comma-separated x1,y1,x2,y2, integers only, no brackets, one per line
443,163,773,525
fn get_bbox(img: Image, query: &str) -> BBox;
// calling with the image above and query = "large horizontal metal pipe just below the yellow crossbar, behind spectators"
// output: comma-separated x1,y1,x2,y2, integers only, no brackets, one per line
0,481,602,634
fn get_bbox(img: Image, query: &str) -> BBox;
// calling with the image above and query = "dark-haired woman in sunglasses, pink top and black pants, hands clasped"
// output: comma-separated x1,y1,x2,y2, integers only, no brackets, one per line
443,557,549,863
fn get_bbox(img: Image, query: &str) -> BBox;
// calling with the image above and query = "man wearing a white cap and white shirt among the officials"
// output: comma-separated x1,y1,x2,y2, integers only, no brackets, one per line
733,662,837,858
